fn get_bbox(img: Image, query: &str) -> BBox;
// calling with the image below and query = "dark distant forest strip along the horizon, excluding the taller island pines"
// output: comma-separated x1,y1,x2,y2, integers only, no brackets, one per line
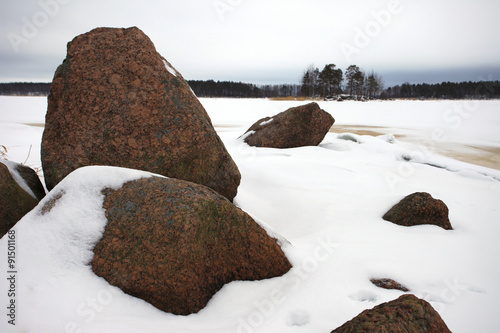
0,80,500,99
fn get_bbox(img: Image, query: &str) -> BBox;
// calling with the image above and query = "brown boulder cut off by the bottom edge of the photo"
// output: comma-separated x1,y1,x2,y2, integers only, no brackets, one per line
332,294,451,333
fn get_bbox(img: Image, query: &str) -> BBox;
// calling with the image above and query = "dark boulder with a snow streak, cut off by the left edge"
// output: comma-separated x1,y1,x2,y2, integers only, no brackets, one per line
0,160,45,238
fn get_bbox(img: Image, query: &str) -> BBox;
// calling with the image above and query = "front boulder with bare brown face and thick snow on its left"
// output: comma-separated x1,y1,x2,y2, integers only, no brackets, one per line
0,166,291,322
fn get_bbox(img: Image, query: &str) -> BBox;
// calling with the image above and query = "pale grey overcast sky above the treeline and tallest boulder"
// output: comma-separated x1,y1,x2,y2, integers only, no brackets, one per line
0,0,500,86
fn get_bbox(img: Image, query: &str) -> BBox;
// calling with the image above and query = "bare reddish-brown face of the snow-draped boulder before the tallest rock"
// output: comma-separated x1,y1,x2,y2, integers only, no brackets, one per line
91,177,291,315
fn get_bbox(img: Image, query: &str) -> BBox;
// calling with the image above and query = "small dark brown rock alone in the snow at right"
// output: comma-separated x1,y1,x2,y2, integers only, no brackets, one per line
382,192,453,230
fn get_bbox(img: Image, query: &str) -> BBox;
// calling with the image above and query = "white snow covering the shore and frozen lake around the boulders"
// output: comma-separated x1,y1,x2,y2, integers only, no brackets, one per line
0,97,500,332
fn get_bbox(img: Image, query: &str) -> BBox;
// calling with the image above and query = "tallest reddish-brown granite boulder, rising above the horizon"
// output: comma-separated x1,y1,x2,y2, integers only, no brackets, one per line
41,27,240,200
